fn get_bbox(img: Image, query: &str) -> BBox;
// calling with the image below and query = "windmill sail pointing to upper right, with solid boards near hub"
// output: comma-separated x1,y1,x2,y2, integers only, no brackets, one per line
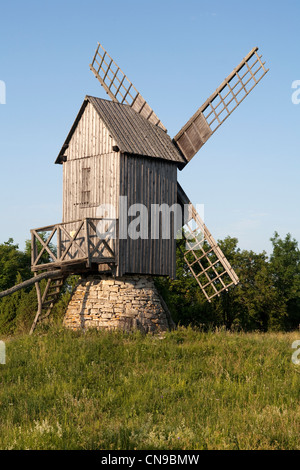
173,47,268,161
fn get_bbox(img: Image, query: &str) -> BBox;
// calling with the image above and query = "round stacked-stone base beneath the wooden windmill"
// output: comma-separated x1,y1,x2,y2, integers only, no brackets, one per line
64,275,174,333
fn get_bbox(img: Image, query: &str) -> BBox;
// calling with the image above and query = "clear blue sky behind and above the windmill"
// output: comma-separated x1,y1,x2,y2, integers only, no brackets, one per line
0,0,300,252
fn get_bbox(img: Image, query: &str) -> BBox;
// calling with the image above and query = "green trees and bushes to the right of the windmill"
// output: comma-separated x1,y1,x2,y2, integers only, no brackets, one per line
156,233,300,331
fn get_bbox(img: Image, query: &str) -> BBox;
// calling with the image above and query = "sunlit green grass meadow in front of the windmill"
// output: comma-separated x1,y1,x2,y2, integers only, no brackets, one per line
0,329,300,450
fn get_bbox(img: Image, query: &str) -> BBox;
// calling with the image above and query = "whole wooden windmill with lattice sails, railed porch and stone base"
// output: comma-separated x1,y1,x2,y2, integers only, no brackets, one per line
27,44,268,331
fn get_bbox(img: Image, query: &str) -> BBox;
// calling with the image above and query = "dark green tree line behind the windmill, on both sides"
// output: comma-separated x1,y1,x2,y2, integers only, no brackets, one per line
0,232,300,335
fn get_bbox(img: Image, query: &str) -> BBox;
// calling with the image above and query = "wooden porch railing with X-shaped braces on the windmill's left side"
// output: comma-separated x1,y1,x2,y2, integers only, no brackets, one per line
31,218,118,271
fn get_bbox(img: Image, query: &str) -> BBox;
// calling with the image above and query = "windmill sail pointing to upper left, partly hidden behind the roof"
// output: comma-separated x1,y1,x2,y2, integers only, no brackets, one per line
90,43,166,131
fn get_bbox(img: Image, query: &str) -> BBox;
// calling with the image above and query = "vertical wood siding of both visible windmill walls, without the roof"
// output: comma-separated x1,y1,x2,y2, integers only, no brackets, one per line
63,103,177,277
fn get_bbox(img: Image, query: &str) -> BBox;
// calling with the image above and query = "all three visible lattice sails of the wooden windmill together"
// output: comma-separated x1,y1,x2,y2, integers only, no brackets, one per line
90,43,268,294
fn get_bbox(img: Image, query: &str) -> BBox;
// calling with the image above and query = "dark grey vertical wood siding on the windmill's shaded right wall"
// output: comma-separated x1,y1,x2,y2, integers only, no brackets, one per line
119,155,177,278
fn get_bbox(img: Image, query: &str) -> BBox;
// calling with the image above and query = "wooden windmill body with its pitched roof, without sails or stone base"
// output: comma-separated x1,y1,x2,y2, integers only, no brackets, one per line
56,96,185,278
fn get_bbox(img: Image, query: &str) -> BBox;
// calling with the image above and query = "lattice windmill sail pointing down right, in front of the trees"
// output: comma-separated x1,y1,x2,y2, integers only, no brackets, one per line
177,183,239,301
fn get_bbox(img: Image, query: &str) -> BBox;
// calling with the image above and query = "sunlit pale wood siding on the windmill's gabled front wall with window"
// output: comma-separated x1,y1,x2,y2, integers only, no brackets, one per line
63,103,120,222
